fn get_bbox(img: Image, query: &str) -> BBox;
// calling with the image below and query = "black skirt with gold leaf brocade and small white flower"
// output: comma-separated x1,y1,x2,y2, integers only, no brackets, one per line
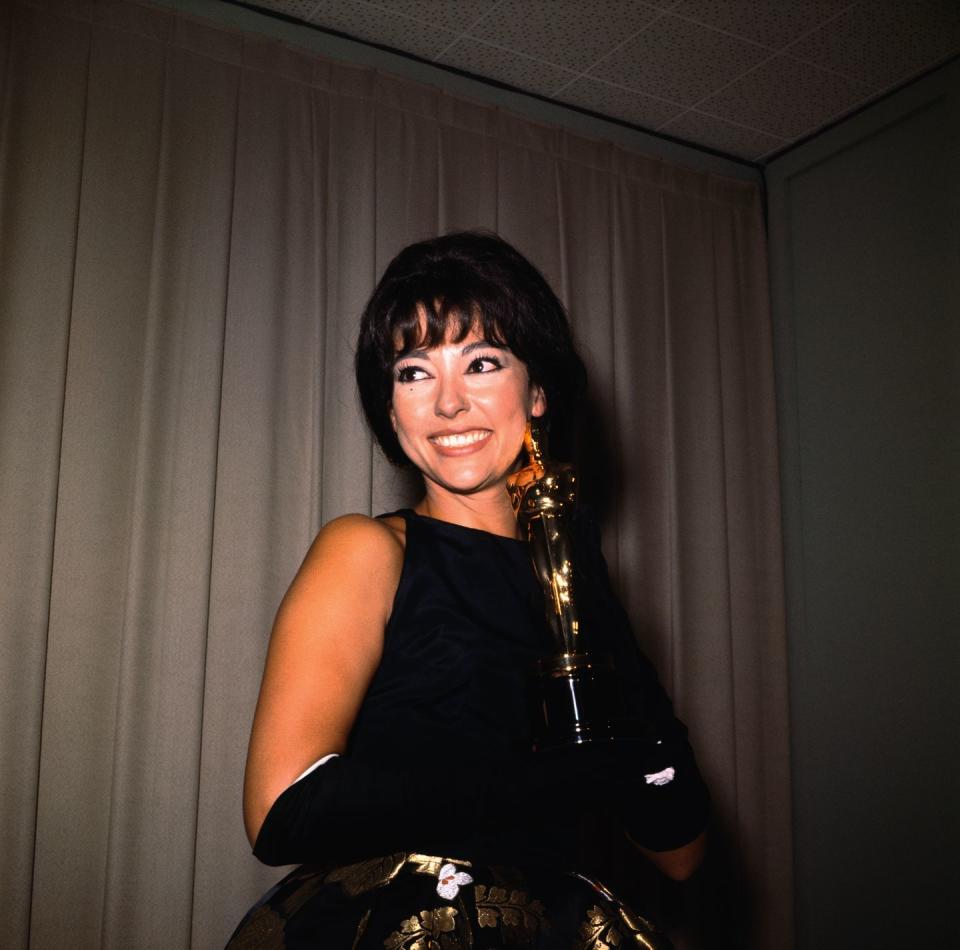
227,853,671,950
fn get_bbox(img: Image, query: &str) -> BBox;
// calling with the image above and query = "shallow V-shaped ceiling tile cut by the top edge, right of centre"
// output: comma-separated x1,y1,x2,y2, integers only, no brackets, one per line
673,0,850,50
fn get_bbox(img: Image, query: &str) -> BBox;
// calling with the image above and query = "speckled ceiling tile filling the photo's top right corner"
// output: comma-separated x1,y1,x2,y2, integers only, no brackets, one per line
790,0,960,92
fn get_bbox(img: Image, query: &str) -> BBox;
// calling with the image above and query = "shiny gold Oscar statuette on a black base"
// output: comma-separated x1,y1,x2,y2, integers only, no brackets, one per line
507,424,639,749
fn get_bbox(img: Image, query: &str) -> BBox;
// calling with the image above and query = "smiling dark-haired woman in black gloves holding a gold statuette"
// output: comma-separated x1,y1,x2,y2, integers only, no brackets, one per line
230,233,706,950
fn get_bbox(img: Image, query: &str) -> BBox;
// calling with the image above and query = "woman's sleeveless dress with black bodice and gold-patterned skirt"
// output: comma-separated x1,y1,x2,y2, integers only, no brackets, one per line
227,509,682,950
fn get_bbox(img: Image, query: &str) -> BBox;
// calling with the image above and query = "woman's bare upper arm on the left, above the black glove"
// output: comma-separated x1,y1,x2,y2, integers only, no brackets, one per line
243,515,403,842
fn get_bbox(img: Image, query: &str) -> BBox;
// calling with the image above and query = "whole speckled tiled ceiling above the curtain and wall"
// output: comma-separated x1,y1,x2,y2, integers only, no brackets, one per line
243,0,960,164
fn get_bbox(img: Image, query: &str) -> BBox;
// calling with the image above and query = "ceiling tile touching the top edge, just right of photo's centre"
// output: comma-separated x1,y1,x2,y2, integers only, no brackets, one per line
470,0,660,72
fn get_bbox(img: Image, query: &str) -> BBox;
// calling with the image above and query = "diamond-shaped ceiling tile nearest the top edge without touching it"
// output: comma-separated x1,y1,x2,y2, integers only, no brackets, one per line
590,14,770,105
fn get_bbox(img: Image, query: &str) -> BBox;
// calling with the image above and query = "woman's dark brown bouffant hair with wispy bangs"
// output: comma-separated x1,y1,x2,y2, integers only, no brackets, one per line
356,231,586,466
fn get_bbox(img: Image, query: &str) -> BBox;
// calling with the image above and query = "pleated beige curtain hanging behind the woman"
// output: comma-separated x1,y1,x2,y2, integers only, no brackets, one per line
0,0,791,950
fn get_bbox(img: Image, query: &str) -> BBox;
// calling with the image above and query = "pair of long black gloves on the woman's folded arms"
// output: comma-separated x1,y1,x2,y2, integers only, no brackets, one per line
253,742,707,866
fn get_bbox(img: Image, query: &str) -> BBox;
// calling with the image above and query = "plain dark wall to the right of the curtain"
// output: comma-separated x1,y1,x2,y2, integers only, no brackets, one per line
767,62,960,950
